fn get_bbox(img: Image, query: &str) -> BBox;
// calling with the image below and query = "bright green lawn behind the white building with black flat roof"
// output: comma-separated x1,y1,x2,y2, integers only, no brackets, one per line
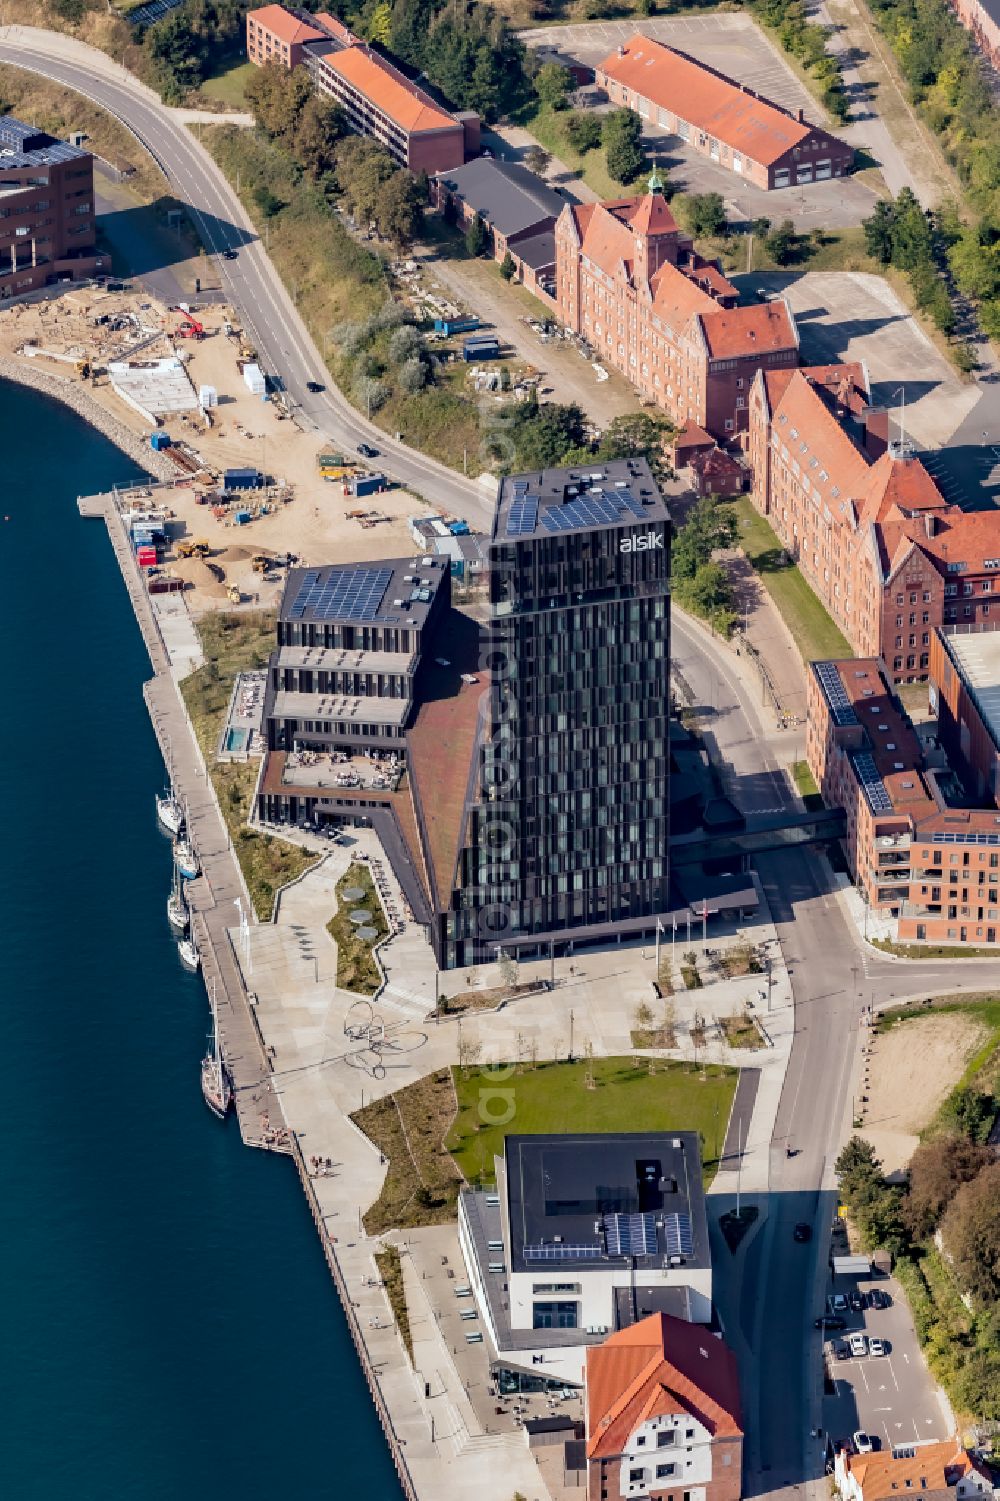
444,1058,739,1186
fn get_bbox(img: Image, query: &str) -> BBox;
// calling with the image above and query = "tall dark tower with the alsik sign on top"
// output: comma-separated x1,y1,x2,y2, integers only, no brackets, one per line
438,459,671,967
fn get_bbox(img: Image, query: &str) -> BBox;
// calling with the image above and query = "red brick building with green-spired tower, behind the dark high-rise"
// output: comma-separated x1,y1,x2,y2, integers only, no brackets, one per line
556,177,799,440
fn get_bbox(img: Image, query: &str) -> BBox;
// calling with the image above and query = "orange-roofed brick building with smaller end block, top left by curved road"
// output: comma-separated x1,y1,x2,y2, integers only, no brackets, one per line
246,5,479,174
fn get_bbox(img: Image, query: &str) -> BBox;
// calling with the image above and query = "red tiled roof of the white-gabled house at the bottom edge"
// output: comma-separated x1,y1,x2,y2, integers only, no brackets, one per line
587,1313,743,1457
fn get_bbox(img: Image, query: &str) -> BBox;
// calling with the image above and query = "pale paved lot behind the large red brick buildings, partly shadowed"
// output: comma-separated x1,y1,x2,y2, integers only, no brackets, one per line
733,272,980,449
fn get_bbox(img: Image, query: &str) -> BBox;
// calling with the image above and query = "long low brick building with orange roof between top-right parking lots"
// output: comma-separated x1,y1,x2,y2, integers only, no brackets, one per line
595,33,854,189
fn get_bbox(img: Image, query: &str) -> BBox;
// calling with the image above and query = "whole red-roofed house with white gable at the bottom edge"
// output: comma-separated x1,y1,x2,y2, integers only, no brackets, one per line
586,1313,743,1501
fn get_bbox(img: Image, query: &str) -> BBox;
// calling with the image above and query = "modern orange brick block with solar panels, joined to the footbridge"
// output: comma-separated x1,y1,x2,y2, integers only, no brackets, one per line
806,657,1000,947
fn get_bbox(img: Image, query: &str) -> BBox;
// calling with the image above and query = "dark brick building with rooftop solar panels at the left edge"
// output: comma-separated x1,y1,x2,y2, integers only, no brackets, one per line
0,114,111,299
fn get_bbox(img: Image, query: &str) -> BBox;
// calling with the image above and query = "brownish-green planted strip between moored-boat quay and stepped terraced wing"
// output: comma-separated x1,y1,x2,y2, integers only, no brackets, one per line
180,611,315,922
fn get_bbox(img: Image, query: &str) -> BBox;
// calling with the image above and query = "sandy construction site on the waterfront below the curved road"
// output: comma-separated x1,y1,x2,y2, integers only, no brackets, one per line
0,288,431,612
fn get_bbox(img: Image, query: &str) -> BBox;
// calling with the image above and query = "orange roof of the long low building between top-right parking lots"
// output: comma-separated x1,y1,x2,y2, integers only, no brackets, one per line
598,35,826,167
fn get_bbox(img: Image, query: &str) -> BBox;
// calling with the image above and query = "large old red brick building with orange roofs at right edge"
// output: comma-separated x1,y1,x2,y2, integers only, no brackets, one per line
749,365,1000,681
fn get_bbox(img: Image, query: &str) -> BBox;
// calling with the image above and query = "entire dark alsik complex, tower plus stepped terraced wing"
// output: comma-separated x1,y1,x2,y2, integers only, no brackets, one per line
258,459,671,968
